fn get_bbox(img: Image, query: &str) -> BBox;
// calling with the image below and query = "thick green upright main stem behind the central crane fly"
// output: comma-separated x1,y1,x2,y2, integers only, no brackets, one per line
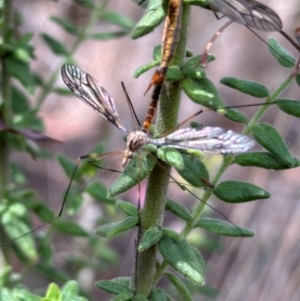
135,5,190,296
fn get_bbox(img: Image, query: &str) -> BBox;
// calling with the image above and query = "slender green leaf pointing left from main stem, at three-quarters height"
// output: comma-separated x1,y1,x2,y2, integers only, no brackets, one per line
96,216,139,238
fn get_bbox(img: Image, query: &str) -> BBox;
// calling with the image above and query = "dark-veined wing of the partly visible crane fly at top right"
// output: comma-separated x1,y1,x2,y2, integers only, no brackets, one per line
208,0,282,32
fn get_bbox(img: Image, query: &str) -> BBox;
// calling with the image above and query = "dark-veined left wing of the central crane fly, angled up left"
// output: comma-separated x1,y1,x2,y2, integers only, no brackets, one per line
61,65,126,133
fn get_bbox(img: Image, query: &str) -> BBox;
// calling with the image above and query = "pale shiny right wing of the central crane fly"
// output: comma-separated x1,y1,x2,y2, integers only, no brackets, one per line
154,127,254,154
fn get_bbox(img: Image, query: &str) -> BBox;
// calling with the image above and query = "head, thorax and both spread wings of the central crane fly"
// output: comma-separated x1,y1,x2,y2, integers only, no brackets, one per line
61,65,254,167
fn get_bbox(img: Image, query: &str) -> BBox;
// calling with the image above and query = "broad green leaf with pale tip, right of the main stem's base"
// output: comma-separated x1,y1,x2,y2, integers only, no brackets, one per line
158,236,205,286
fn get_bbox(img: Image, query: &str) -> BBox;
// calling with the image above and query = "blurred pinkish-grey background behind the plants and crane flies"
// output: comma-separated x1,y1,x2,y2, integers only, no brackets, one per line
5,0,300,301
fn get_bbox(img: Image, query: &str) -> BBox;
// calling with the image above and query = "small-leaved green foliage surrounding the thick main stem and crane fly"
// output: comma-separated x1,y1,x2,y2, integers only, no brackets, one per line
0,0,300,301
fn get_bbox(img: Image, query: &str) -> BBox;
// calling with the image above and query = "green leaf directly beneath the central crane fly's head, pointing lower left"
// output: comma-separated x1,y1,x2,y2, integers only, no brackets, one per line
107,154,156,198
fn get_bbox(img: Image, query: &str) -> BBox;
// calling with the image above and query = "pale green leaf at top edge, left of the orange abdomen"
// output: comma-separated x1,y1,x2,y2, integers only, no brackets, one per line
131,0,166,39
